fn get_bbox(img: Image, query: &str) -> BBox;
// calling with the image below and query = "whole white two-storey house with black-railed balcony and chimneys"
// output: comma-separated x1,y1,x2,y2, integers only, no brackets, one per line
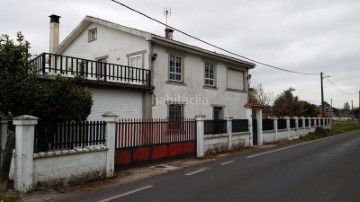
33,15,255,120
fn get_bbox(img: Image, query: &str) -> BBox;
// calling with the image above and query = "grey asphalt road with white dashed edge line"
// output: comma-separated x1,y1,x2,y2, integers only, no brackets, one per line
58,131,360,202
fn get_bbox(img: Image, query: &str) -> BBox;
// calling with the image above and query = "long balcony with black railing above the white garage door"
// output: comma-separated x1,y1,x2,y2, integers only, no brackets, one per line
29,53,151,88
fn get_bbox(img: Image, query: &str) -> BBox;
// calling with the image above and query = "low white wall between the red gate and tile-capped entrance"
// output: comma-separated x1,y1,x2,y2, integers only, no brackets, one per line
204,132,250,155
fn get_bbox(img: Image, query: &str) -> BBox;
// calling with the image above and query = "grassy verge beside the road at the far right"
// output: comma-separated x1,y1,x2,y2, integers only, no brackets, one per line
300,122,360,140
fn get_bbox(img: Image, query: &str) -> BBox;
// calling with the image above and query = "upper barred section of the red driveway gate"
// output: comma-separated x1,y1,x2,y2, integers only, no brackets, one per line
115,119,196,149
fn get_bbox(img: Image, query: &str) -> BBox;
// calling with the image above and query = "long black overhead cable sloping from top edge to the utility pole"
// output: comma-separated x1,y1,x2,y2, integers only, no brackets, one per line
111,0,318,75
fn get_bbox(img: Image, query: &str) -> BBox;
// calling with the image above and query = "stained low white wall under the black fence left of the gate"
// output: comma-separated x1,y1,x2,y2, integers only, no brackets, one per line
33,146,108,186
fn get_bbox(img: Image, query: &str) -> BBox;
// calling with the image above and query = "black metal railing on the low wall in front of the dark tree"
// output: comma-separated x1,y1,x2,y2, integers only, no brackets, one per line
34,121,106,153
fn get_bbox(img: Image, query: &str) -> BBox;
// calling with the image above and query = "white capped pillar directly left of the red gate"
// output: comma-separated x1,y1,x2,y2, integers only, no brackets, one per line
102,112,118,177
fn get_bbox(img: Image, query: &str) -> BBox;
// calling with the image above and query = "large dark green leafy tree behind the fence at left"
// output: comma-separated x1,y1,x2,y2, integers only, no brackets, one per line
0,33,93,120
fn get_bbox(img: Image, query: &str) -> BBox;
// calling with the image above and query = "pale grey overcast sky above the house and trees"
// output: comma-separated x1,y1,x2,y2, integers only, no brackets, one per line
0,0,360,108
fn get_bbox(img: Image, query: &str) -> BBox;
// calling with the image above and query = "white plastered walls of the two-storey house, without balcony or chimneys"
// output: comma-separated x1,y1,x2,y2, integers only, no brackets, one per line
55,17,255,120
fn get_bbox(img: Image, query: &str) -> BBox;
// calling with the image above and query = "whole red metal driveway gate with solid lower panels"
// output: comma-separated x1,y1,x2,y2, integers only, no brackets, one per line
115,120,196,166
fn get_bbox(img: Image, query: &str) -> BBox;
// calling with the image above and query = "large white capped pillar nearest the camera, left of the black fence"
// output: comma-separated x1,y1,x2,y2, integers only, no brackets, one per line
13,115,38,192
